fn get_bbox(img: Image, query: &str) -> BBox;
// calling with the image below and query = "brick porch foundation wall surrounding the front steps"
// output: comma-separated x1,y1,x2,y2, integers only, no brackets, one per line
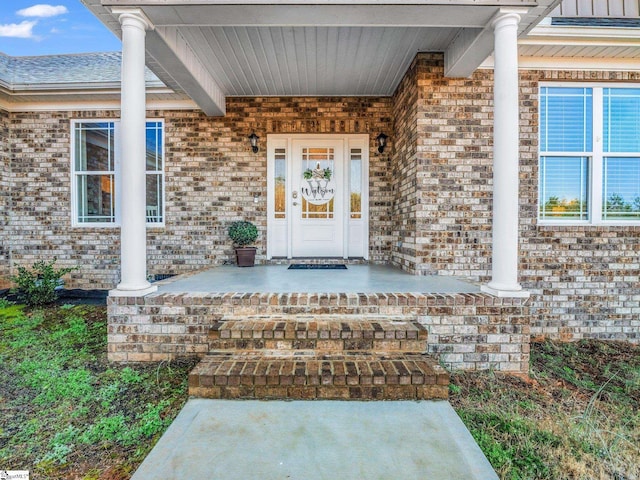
108,293,529,372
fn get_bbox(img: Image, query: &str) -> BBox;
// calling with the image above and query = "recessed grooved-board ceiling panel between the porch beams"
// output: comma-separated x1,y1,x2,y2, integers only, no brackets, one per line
175,27,457,96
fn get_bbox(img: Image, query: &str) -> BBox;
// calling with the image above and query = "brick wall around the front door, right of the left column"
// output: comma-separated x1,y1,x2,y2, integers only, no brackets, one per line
155,97,392,273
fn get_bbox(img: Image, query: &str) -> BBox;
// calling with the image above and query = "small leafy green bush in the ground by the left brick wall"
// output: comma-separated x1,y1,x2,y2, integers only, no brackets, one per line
11,258,77,307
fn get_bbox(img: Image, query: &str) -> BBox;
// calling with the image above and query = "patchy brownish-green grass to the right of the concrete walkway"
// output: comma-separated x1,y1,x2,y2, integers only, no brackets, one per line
451,341,640,480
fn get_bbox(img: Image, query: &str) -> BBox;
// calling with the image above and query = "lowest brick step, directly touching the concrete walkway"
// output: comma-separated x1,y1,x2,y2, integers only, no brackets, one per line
189,351,449,400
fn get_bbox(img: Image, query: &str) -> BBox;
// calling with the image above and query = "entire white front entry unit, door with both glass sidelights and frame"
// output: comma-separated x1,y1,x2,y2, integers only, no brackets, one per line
267,134,369,258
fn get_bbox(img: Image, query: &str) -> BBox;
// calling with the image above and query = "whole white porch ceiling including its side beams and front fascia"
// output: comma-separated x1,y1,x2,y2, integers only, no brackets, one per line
82,0,559,115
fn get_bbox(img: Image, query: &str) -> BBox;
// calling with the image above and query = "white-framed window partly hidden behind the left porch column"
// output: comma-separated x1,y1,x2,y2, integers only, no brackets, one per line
72,121,164,226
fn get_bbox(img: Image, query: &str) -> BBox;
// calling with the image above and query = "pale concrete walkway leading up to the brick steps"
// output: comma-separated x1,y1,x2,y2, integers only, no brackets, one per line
133,399,498,480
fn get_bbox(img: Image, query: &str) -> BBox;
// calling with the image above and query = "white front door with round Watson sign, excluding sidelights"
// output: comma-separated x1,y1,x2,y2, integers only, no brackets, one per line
290,139,345,257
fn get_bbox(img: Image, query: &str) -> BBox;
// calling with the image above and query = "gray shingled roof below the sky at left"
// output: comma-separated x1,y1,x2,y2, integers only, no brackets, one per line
0,52,163,88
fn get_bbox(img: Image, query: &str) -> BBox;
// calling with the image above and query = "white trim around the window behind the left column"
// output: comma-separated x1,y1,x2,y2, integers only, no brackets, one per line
70,118,167,228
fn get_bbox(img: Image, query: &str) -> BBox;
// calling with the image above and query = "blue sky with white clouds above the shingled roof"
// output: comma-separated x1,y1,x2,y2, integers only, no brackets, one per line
0,0,121,56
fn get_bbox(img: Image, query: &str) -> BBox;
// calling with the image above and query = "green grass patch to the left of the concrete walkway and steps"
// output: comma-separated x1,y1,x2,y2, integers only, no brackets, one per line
0,302,194,479
